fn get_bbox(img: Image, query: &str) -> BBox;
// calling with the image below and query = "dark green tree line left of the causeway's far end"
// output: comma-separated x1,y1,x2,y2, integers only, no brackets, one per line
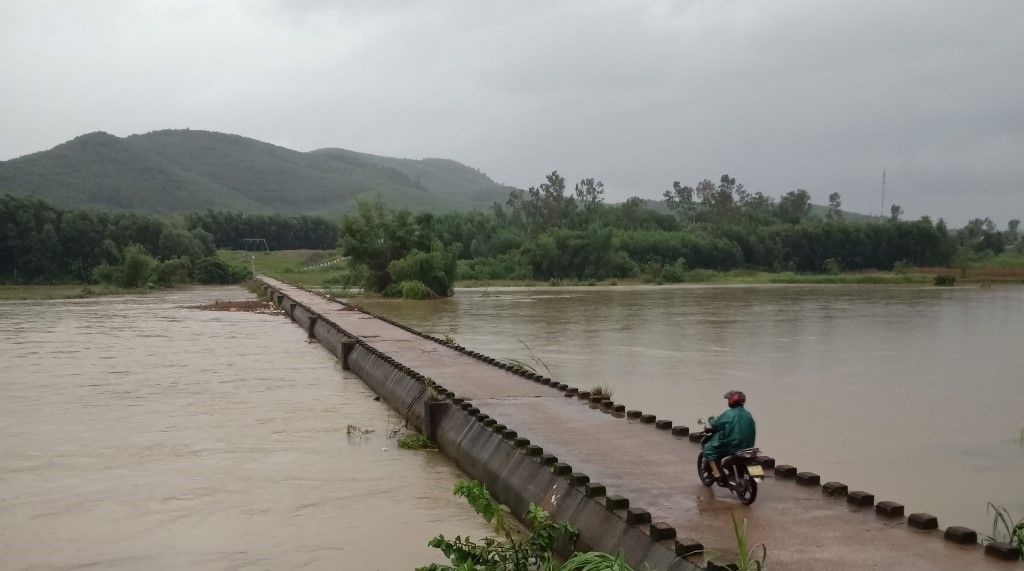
0,194,327,288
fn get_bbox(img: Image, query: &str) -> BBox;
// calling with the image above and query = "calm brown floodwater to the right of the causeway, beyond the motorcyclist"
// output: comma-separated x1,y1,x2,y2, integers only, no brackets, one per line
360,286,1024,532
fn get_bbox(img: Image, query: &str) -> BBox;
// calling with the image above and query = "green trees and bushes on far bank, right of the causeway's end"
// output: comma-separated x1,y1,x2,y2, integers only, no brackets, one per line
339,171,1020,296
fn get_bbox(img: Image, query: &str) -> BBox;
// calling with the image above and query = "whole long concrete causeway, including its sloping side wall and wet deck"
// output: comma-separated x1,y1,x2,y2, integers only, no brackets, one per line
259,276,1022,570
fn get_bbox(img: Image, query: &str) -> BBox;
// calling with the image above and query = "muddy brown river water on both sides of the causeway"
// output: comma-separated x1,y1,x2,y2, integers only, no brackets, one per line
0,286,1024,569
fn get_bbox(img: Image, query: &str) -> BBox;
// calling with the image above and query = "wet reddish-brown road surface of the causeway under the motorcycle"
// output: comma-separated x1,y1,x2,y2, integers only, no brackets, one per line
265,278,1020,570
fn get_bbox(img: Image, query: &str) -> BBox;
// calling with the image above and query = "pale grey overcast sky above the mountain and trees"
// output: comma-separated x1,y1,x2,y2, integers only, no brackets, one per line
0,0,1024,224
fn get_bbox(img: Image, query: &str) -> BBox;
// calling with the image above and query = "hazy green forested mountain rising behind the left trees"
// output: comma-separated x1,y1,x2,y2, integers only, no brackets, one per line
0,129,509,216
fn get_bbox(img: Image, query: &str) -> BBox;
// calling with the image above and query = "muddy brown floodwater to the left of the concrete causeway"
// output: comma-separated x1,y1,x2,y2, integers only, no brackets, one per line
0,288,487,570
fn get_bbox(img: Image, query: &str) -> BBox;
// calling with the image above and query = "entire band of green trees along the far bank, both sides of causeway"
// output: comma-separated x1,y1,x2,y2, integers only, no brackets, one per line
0,172,1021,296
